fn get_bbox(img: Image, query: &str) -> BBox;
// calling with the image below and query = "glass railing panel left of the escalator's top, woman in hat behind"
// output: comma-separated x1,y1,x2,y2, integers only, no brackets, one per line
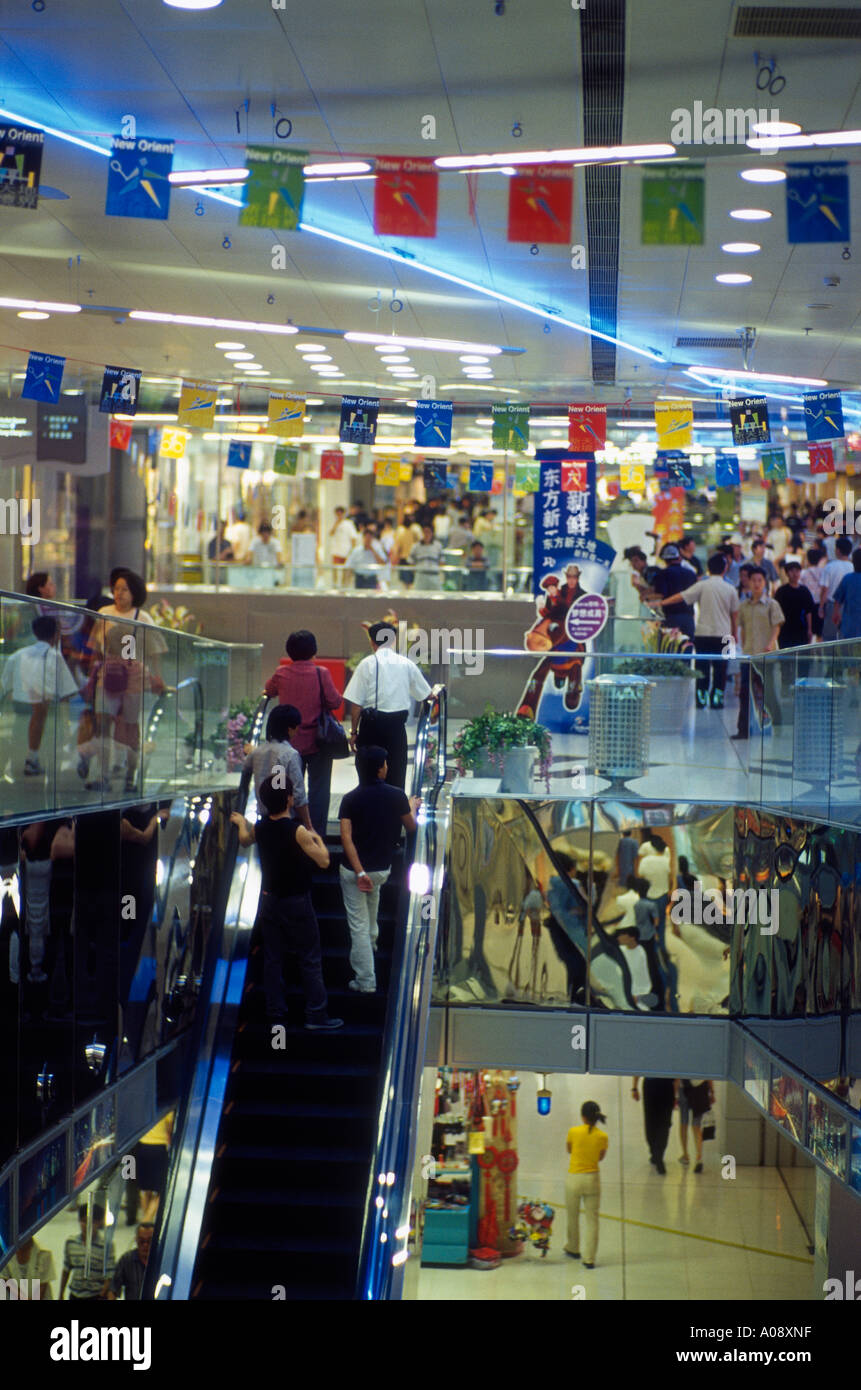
0,594,261,820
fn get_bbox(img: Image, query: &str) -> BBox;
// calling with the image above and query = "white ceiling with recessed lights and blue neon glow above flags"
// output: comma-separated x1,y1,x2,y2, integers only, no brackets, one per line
0,0,861,402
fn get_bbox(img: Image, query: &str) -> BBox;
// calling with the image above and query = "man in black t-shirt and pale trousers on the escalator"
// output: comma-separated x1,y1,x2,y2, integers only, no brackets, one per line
338,746,421,994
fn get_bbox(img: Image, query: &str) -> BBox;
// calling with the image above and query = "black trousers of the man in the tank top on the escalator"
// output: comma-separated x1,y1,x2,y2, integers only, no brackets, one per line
257,892,328,1023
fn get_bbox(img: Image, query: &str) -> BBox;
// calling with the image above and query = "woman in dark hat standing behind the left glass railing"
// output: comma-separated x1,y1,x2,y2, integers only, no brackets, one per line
78,567,167,792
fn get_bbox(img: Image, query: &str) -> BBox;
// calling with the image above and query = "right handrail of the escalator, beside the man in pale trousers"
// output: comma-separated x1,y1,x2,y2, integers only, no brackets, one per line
356,685,446,1300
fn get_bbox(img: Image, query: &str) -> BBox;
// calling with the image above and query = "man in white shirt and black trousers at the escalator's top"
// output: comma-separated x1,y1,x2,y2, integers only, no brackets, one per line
344,623,431,788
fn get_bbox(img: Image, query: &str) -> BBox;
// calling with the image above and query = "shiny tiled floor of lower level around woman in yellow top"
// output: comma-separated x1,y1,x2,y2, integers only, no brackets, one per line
417,1073,821,1302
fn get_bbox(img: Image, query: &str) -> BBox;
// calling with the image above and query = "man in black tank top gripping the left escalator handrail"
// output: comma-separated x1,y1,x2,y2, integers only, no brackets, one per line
231,769,344,1031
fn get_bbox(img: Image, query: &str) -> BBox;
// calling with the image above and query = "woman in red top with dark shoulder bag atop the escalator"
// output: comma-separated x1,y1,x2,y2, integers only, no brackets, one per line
264,628,343,840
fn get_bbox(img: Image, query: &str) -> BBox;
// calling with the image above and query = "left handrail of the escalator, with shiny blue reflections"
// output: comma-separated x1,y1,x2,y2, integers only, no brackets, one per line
143,695,270,1298
